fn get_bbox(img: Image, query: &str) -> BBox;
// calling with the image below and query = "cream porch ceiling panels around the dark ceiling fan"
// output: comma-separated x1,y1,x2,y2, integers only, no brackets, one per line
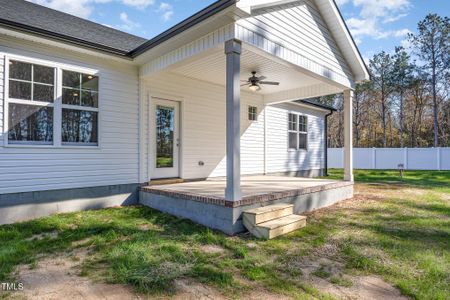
149,44,343,104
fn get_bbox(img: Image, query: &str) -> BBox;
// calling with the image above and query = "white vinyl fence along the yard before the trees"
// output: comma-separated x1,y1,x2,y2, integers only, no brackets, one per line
328,148,450,170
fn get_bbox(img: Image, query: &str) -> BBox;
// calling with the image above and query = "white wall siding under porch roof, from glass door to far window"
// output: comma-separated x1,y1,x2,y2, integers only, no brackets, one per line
147,74,325,179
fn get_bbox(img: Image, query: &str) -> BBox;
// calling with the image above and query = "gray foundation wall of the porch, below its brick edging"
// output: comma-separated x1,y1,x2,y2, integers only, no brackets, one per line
139,185,353,235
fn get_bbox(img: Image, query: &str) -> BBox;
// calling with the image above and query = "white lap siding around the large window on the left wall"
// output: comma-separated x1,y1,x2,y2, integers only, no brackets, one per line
0,38,139,194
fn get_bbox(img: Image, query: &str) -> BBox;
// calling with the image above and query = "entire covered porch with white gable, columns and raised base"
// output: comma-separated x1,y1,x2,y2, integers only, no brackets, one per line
140,0,368,234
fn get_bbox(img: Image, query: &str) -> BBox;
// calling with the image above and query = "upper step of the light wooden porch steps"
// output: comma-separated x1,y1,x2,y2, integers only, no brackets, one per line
243,204,294,226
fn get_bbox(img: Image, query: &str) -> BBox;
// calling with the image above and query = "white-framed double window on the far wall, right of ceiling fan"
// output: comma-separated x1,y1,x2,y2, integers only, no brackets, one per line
288,113,308,150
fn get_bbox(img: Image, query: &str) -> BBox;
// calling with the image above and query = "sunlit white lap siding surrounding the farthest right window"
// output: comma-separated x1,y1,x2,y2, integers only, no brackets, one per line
267,104,324,173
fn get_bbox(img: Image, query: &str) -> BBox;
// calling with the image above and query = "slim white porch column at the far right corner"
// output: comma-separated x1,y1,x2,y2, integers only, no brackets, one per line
344,90,354,181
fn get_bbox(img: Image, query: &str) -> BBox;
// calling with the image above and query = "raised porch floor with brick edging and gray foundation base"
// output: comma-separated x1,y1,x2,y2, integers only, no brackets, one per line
139,175,353,235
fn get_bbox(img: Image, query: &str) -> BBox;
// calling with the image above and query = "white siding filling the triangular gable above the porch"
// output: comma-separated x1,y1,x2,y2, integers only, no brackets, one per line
236,0,353,84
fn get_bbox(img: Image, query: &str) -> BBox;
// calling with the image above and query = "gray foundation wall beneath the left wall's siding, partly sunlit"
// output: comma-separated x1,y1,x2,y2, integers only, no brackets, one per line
0,184,139,225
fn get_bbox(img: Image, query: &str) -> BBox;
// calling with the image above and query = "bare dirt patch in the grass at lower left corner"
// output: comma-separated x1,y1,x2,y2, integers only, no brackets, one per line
12,249,141,300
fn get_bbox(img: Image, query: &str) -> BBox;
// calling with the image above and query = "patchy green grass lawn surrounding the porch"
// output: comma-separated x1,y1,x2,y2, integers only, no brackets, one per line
0,170,450,299
